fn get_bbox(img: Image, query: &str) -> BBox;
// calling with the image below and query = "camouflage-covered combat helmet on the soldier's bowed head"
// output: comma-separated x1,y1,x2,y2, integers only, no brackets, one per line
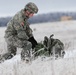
24,2,38,13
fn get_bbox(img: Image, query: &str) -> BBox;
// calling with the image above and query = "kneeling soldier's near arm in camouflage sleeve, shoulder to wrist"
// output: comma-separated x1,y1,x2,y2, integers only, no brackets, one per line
13,14,29,40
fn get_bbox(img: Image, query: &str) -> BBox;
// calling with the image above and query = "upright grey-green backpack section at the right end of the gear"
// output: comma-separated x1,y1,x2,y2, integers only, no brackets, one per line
44,34,65,58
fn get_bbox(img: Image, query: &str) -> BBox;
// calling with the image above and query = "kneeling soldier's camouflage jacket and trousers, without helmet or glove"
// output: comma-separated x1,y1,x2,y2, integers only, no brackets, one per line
3,9,33,59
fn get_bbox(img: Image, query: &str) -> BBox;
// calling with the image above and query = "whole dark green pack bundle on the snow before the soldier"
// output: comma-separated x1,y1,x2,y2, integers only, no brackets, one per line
34,34,65,59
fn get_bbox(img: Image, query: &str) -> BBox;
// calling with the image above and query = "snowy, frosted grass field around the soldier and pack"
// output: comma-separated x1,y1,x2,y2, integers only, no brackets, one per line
0,21,76,75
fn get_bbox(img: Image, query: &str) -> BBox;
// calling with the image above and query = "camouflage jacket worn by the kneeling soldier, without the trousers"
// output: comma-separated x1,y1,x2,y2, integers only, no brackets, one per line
5,10,32,40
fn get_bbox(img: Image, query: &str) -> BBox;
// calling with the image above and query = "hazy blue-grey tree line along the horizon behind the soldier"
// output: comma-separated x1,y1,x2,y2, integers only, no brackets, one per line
0,12,76,27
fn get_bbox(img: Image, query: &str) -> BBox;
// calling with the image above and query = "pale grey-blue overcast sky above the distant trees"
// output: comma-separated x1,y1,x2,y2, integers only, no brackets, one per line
0,0,76,17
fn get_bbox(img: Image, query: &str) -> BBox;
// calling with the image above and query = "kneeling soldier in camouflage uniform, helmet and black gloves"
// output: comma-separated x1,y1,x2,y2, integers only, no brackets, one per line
0,2,38,60
